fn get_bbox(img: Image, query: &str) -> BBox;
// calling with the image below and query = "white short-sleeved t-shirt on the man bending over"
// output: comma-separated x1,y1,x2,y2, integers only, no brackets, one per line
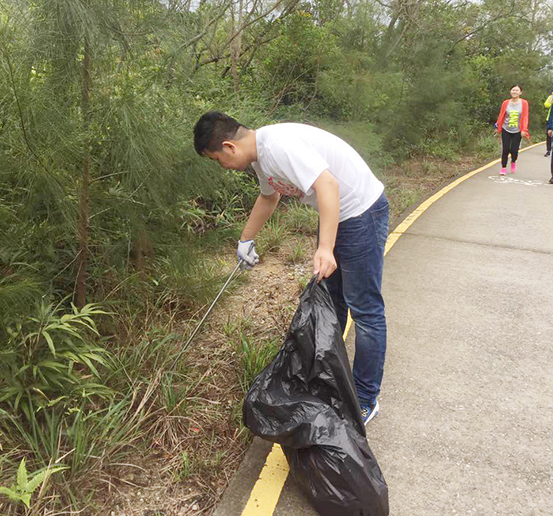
252,124,384,222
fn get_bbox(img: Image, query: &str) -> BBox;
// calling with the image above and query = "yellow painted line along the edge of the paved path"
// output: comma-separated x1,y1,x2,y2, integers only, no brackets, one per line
238,142,545,516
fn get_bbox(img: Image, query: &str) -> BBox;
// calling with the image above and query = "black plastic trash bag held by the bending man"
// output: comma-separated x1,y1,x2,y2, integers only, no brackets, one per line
243,280,389,516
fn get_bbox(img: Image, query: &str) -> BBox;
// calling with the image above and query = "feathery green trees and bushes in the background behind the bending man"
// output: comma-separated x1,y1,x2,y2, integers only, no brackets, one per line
0,0,553,317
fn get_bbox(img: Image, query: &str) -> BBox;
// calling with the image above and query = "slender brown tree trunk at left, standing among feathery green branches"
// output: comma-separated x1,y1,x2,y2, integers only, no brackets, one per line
75,36,92,308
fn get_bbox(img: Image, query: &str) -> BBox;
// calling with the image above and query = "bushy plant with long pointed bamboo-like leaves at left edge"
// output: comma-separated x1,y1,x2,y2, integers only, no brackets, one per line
0,303,110,419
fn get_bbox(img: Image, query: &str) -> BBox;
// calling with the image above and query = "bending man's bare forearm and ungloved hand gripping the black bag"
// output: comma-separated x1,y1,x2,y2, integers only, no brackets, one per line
312,170,340,281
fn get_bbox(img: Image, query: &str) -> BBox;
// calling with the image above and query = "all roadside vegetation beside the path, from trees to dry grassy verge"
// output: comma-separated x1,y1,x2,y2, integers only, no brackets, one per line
0,0,553,515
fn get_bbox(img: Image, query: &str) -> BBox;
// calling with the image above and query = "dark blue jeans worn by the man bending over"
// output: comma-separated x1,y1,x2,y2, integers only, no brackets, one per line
327,193,390,405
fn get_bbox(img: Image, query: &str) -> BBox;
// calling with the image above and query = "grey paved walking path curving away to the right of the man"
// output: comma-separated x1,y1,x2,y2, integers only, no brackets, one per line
212,142,553,516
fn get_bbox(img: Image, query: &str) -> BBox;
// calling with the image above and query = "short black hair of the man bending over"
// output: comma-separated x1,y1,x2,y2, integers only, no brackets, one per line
194,111,246,156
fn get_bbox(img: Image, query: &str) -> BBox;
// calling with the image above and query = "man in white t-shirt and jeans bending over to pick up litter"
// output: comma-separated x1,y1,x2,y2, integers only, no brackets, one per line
194,111,389,424
